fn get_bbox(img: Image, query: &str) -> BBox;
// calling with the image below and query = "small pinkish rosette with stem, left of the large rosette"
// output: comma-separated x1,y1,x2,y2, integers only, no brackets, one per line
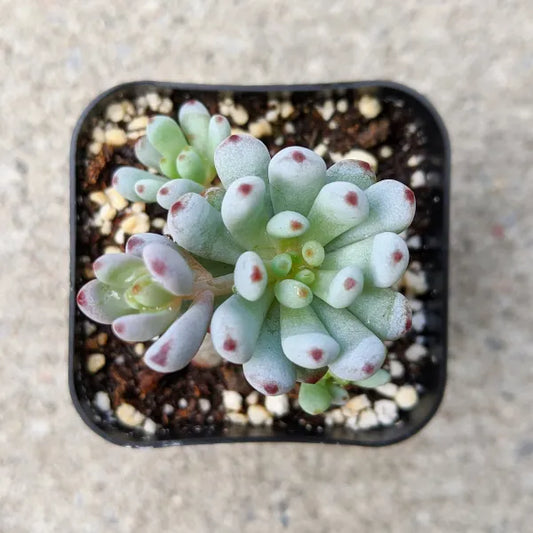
77,233,233,372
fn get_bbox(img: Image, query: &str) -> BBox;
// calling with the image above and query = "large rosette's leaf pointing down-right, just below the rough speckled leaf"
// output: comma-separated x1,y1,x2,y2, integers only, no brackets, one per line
312,299,386,381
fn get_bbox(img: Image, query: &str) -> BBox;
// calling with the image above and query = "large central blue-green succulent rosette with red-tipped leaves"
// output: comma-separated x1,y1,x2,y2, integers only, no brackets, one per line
166,134,415,413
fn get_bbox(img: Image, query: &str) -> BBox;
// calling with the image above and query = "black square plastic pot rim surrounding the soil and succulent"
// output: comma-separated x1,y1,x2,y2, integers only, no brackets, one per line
69,81,450,447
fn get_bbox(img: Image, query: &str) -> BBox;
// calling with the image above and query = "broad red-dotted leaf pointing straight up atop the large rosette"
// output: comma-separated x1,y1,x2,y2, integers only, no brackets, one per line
268,147,326,215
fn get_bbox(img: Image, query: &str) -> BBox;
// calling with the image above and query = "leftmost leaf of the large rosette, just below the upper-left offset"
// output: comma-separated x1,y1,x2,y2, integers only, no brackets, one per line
168,193,244,264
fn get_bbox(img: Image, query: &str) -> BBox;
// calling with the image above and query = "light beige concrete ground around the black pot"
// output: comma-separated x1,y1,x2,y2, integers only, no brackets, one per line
0,0,533,533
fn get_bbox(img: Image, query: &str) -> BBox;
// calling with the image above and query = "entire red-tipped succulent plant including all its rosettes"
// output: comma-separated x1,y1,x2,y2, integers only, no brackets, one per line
78,101,415,414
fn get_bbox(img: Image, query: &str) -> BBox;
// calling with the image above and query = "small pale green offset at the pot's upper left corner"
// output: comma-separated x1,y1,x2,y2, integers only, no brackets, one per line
112,100,231,209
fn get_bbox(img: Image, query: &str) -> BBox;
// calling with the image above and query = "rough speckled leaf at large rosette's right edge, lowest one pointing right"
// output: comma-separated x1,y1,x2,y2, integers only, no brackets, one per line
348,287,412,340
